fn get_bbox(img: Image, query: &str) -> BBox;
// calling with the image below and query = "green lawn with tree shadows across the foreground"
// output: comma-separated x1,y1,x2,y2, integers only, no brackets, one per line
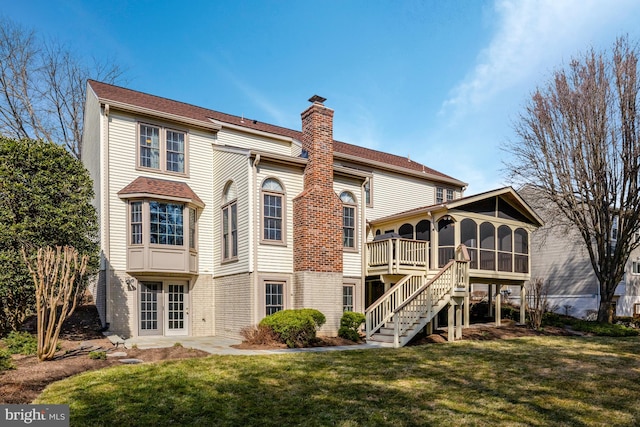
34,337,640,426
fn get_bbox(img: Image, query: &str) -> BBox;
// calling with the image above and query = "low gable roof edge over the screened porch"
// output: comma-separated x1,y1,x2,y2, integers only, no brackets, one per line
369,187,544,227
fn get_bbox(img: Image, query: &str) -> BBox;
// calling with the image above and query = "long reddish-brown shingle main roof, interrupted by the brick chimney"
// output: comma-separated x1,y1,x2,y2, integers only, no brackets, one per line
89,80,457,181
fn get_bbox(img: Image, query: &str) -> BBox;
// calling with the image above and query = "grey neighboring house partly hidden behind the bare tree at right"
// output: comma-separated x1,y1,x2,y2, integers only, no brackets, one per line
520,186,640,318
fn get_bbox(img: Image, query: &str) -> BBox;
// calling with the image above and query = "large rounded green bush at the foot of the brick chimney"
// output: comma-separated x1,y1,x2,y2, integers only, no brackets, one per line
260,308,326,348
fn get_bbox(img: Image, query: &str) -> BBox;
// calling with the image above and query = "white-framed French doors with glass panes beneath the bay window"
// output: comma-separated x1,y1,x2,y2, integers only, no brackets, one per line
138,280,189,335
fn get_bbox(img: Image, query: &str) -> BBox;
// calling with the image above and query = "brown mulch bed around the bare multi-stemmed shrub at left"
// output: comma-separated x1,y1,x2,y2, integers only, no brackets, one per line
0,305,208,404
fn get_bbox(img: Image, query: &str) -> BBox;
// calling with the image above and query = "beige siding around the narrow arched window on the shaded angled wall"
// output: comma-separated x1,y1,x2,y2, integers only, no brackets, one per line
210,150,252,277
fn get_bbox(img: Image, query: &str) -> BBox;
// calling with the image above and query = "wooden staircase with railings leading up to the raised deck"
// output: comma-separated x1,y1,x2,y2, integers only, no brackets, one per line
365,245,469,347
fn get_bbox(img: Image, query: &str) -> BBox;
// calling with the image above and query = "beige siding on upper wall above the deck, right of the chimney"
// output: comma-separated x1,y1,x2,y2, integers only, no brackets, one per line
367,170,435,220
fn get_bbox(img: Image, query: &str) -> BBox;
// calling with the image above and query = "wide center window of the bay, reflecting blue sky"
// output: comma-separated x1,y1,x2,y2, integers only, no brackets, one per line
149,202,184,246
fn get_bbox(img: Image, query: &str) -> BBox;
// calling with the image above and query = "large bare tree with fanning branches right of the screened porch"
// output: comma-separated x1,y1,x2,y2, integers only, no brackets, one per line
507,37,640,322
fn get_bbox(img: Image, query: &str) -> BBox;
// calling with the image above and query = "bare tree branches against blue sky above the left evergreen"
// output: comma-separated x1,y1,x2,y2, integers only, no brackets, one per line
0,18,123,158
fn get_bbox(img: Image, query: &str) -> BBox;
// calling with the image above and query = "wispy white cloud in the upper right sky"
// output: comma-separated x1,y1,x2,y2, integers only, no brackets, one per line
440,0,640,119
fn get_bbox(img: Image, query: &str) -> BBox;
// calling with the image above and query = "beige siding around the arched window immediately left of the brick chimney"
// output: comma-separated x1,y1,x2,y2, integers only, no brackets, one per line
254,161,303,273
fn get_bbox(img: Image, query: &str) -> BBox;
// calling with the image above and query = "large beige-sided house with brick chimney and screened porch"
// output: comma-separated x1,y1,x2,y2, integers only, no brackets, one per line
82,81,541,345
